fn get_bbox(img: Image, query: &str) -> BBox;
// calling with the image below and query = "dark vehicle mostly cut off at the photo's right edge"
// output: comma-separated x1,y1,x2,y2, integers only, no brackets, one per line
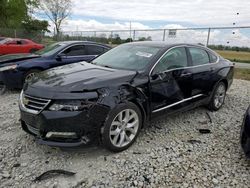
240,106,250,158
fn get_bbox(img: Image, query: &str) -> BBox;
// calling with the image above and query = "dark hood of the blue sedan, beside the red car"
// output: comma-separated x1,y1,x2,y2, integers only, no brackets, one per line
0,54,41,66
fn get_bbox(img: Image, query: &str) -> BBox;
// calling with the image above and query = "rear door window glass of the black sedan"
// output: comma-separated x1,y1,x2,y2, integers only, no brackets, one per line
189,48,210,66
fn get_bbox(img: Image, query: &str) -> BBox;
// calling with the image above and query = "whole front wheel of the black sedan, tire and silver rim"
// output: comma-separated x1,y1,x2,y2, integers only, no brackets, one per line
102,102,142,152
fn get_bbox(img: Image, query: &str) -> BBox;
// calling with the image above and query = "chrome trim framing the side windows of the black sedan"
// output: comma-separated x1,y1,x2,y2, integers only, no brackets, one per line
149,45,220,76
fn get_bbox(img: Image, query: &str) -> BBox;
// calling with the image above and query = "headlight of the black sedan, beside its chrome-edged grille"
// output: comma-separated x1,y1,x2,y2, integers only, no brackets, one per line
49,100,93,111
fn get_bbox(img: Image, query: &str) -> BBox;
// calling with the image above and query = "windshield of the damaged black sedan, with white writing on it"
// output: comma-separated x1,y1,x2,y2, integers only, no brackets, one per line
92,44,160,70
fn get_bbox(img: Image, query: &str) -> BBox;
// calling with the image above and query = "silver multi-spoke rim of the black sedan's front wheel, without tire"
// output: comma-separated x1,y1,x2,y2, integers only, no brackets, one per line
109,109,139,148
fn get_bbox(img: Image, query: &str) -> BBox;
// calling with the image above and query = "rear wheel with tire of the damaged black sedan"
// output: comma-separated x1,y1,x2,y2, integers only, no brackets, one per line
208,82,226,111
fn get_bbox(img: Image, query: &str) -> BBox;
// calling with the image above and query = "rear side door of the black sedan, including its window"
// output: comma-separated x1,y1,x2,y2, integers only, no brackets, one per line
188,47,214,97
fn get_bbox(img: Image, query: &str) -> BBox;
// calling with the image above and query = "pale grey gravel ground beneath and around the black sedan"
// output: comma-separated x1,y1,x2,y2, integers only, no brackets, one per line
0,80,250,187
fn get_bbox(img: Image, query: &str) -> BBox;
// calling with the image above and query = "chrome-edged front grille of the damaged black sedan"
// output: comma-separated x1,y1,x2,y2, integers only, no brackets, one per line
20,92,50,114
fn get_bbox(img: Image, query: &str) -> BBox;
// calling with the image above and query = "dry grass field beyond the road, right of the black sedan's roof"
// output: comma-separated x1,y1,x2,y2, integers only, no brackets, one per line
215,50,250,63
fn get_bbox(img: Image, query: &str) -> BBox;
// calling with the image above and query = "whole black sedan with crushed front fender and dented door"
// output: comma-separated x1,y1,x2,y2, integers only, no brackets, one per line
20,42,234,151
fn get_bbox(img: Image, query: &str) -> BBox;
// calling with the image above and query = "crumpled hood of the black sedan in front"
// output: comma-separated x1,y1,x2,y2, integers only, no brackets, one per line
26,62,136,95
